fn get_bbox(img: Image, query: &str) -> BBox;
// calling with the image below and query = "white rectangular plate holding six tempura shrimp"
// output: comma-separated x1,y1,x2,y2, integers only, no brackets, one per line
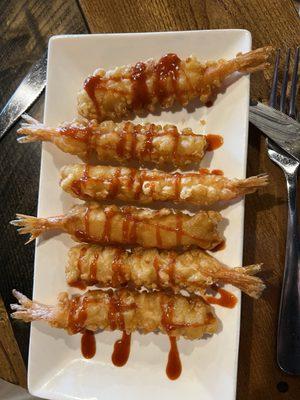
29,30,251,400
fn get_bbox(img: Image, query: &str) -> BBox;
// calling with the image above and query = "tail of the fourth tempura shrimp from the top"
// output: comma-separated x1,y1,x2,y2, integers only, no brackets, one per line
10,214,61,244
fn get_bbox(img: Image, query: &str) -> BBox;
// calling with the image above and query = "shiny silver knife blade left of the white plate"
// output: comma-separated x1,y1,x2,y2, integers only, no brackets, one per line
0,52,47,140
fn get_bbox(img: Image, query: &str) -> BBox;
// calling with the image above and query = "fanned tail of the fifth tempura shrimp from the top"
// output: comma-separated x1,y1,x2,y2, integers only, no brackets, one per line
219,264,266,299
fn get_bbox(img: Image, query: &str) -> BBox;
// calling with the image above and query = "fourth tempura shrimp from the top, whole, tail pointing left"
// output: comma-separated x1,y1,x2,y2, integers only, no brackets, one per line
11,203,223,249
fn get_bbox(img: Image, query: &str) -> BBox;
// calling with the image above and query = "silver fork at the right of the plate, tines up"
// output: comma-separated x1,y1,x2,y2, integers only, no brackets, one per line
268,48,300,375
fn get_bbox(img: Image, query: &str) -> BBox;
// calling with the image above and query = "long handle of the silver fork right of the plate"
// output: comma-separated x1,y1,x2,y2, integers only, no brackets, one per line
277,167,300,375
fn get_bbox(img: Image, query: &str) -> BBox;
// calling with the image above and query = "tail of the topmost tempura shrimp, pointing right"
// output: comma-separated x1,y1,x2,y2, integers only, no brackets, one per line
235,46,273,73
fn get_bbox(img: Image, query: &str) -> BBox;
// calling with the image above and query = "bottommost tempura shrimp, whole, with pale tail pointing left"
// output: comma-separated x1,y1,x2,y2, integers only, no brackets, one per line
11,289,217,340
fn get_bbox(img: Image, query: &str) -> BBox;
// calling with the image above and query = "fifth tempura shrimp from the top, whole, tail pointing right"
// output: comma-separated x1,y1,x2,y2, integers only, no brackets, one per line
66,244,265,298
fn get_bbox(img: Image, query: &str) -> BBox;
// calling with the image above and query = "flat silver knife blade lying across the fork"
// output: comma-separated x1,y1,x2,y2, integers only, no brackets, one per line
249,102,300,161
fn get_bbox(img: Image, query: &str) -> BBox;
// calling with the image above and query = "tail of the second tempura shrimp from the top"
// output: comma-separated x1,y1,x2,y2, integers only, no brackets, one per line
17,114,55,143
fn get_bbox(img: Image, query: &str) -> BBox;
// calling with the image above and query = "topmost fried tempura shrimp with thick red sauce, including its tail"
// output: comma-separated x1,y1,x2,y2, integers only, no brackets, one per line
78,47,272,121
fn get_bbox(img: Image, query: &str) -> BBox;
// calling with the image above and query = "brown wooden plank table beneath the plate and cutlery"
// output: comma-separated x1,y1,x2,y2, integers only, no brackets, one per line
0,0,300,400
